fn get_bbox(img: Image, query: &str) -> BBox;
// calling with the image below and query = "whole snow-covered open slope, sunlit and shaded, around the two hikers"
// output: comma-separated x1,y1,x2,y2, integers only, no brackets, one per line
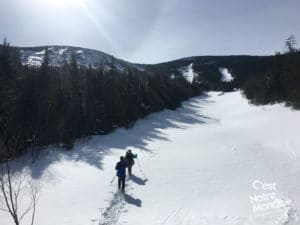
0,92,300,225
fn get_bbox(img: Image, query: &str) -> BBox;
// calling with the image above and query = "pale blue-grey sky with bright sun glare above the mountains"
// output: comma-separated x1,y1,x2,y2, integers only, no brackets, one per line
0,0,300,63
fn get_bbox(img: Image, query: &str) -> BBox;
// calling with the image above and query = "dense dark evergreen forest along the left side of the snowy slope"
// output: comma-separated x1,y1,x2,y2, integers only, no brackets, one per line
0,41,200,161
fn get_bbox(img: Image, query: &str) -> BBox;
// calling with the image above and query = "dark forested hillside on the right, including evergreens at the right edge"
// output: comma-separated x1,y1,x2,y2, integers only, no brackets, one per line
152,35,300,109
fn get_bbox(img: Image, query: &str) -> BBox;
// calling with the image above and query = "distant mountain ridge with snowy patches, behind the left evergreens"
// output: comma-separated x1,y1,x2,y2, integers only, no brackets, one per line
12,45,273,90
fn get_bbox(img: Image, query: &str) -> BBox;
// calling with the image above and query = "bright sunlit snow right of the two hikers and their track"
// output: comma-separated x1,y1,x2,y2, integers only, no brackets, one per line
118,92,300,225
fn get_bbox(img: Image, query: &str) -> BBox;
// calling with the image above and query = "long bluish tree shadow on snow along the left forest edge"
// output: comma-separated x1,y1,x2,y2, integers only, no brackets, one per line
22,92,217,178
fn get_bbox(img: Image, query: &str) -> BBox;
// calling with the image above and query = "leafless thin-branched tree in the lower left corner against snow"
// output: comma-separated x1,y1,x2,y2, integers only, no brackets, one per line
0,123,40,225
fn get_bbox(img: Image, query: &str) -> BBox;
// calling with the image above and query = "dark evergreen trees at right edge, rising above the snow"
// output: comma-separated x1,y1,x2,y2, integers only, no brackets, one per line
241,35,300,109
